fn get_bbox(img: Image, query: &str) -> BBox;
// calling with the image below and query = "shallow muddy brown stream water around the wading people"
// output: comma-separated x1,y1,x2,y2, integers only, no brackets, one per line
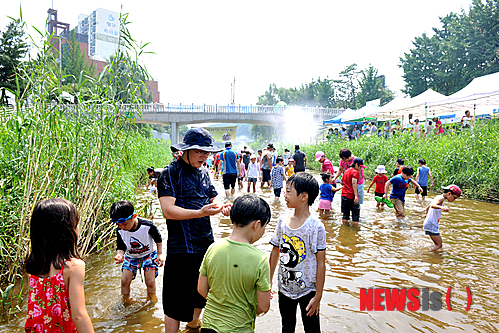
0,170,499,332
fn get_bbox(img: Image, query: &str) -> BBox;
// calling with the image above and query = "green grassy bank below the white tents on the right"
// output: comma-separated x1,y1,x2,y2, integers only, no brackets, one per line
302,120,499,202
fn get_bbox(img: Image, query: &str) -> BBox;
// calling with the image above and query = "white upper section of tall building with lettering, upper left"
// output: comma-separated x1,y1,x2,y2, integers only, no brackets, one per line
75,8,120,61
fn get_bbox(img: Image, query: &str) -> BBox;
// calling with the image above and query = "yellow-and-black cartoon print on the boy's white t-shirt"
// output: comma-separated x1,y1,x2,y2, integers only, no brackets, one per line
279,234,307,289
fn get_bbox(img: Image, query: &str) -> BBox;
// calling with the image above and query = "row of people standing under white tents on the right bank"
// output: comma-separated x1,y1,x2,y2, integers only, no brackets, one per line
326,110,473,141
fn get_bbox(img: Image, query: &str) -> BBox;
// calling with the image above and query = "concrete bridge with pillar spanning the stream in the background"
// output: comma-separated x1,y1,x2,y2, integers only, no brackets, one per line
121,104,344,144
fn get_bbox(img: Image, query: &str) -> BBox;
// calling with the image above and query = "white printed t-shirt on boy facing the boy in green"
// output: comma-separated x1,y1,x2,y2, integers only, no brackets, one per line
270,215,326,299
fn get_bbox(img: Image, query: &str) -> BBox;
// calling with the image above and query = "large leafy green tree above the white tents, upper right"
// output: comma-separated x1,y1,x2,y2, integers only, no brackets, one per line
399,0,499,97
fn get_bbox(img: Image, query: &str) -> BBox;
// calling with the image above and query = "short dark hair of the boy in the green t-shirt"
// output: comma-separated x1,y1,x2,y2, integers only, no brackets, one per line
230,194,271,227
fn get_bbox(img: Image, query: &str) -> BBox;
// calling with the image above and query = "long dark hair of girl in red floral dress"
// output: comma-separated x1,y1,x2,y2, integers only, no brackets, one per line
25,199,80,276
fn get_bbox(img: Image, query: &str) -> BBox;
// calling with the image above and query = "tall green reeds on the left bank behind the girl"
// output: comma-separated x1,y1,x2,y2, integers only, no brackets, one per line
0,12,170,313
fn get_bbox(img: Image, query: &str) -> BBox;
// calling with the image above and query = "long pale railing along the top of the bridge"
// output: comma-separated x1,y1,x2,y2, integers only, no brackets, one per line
120,103,344,116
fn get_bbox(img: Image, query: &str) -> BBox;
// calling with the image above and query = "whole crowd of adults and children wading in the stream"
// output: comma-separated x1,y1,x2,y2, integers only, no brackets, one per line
25,128,461,333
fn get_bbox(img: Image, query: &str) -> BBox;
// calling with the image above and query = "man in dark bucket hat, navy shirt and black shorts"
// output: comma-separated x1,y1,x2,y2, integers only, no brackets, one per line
158,128,230,333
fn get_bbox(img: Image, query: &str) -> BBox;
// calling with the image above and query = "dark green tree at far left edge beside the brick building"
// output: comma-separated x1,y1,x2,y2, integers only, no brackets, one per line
0,20,28,104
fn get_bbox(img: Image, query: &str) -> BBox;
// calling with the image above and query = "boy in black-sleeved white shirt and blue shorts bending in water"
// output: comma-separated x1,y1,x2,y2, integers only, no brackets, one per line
110,200,165,301
